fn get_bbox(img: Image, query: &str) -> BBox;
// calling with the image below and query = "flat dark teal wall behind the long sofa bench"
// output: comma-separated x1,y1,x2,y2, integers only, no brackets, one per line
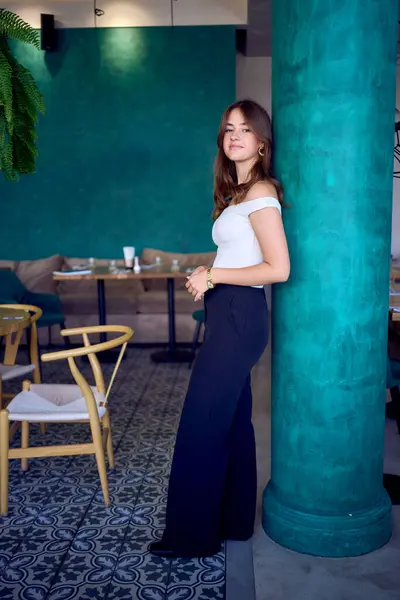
0,27,235,260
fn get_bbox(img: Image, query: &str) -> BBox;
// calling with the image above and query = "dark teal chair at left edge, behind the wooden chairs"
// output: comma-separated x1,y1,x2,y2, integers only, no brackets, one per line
0,270,69,347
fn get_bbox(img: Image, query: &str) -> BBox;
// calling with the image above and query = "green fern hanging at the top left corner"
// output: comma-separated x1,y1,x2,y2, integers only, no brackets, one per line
0,8,45,181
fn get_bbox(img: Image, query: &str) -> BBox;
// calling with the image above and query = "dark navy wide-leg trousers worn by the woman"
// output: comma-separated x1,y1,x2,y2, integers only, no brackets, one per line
163,285,268,556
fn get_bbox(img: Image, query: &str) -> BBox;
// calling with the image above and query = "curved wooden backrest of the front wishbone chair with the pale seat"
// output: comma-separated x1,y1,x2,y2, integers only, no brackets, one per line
42,325,133,410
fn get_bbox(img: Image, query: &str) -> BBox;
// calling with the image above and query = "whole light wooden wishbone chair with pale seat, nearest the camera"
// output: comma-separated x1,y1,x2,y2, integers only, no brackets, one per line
0,325,133,515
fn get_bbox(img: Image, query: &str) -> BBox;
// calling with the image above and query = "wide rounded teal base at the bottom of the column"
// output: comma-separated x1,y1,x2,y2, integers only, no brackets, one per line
262,481,392,558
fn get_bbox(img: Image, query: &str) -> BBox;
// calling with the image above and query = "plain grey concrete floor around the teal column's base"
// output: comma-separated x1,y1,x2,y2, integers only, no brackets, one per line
252,350,400,600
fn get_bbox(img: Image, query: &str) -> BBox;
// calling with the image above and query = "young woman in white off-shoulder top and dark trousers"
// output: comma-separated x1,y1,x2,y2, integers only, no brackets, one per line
150,100,290,558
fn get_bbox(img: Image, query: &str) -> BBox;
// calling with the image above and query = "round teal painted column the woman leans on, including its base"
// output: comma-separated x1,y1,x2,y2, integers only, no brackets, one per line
263,0,397,557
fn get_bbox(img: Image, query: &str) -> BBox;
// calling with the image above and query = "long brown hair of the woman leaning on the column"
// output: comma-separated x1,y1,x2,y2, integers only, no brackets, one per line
213,100,283,220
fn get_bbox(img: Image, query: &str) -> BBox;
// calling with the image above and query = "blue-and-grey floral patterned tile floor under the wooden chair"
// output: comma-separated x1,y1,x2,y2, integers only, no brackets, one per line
0,349,225,600
